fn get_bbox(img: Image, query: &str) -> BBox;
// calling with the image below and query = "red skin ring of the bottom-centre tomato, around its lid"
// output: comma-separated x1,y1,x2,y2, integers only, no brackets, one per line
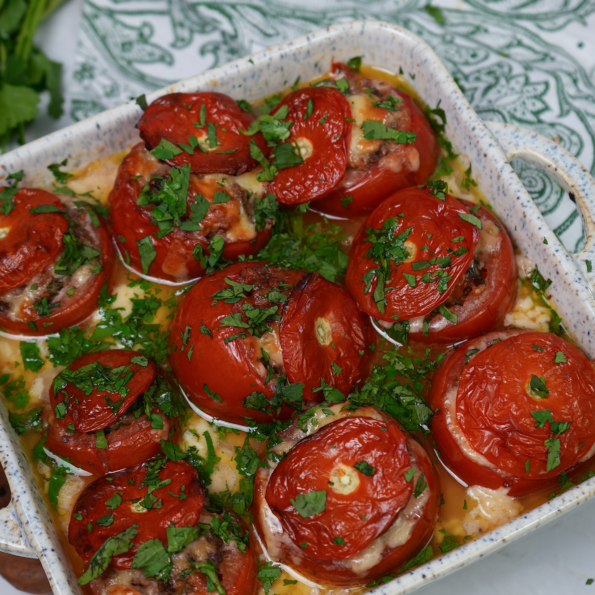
253,407,440,585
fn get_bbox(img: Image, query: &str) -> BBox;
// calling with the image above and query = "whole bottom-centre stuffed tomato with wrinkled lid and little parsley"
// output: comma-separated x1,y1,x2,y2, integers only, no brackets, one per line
253,404,440,585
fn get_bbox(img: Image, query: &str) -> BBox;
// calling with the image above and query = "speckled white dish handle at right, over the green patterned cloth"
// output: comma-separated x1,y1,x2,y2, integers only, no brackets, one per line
486,122,595,294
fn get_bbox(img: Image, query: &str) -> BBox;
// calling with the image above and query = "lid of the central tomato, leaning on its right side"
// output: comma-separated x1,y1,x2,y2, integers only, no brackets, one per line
280,274,374,402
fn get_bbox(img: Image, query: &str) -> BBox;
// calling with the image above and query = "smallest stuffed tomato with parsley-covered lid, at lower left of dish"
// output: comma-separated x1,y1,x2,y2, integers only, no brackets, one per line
44,349,182,475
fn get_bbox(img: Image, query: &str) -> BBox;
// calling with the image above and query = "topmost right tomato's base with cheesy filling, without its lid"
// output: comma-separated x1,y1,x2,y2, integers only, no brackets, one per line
314,63,439,217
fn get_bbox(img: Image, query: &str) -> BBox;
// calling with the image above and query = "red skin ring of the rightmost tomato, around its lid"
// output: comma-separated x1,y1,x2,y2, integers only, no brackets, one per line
428,330,592,497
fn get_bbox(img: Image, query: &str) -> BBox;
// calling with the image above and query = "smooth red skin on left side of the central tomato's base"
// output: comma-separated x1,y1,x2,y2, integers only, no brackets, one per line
169,262,304,424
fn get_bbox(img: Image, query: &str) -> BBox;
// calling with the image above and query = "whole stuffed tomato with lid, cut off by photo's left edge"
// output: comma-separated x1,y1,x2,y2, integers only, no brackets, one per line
0,188,114,335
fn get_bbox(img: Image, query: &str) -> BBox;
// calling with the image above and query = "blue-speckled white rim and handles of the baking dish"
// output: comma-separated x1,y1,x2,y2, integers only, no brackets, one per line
0,21,595,595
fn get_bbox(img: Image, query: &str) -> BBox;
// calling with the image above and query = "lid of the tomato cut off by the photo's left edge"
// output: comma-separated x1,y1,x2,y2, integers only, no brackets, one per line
0,188,68,293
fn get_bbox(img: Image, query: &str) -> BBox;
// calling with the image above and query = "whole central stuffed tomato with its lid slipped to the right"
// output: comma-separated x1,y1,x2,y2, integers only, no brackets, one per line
170,262,373,423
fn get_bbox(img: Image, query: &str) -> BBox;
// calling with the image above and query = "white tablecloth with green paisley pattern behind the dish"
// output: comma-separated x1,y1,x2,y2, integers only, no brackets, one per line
71,0,595,251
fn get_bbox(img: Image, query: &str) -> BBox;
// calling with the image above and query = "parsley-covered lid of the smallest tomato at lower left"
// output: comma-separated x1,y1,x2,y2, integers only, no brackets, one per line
50,349,157,432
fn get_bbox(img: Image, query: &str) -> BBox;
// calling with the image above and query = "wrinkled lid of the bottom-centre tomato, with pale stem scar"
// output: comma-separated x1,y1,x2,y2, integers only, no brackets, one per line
265,417,413,560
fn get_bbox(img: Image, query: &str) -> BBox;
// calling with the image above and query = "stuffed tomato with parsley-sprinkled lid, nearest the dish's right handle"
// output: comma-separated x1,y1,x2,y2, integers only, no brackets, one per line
346,184,516,344
